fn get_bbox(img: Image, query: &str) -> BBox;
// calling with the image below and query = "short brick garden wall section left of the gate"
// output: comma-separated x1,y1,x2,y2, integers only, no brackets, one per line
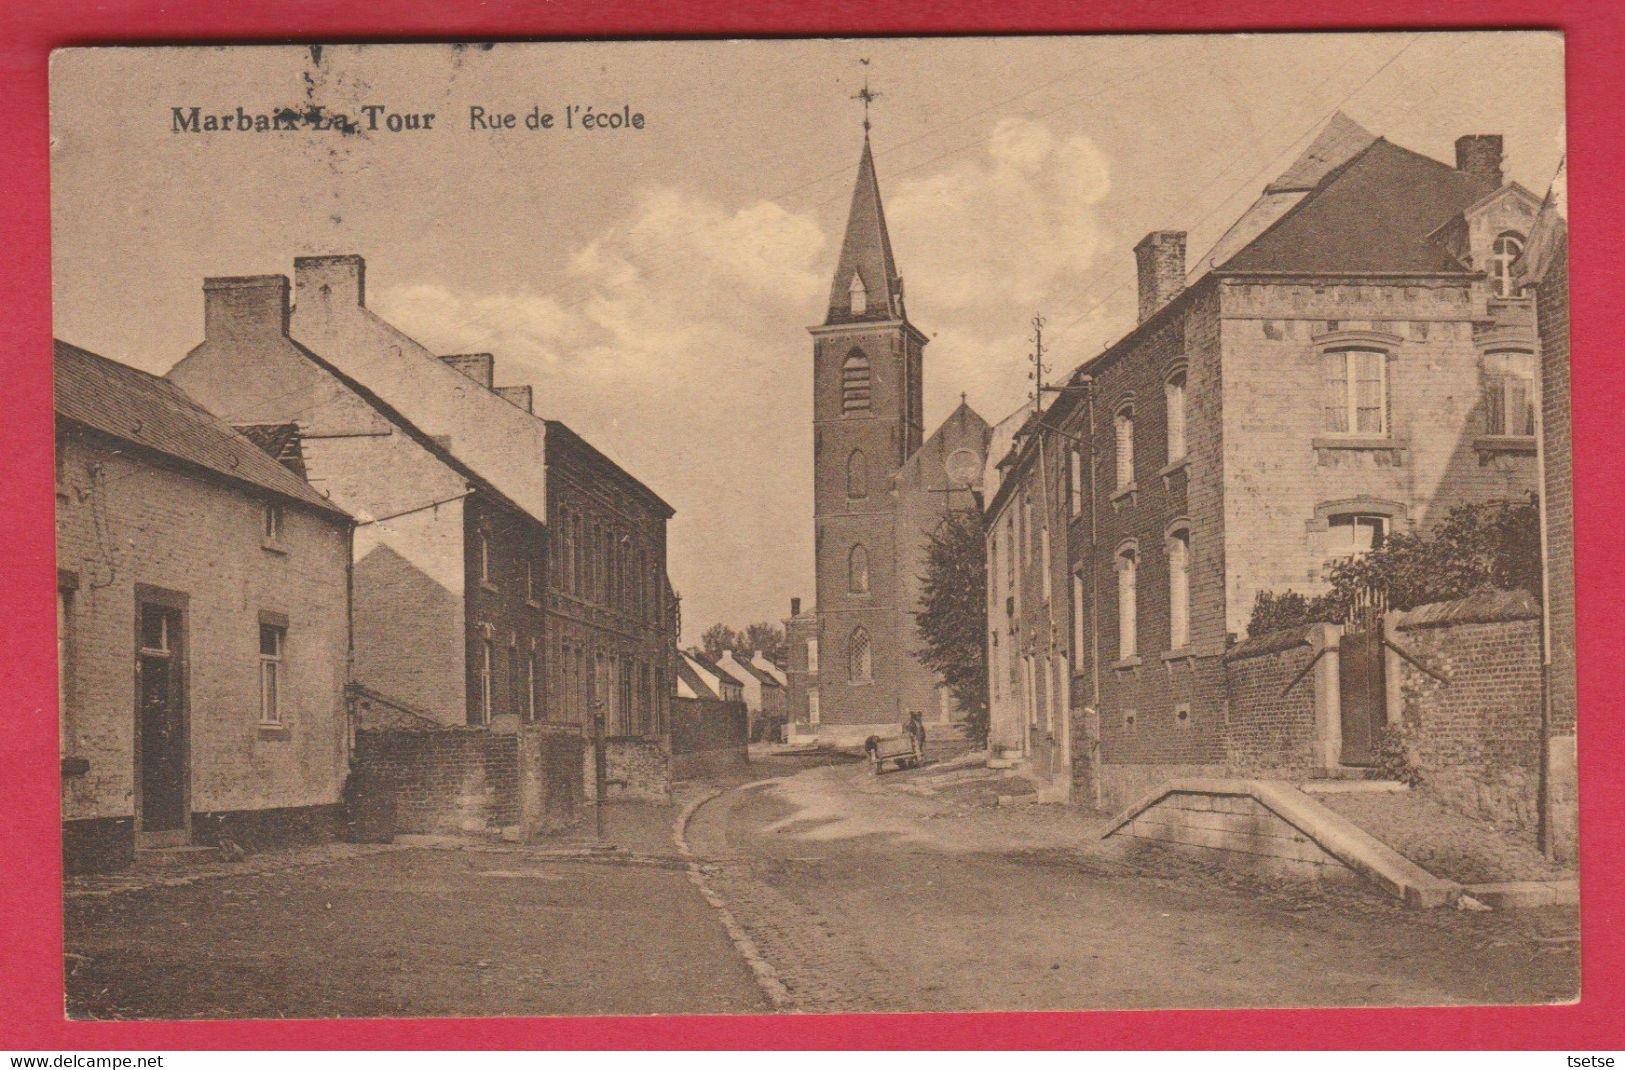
1224,628,1321,777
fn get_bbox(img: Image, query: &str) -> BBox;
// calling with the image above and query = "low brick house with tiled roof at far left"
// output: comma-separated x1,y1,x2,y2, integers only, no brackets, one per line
55,341,353,870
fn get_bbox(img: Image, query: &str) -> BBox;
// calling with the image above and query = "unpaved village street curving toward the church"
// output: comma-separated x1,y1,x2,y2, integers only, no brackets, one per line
67,758,1578,1018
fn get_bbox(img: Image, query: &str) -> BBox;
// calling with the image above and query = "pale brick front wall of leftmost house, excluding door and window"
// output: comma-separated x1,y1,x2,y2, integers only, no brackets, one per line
57,434,349,865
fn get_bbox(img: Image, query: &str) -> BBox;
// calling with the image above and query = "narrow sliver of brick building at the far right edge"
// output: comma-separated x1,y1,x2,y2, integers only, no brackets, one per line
1515,156,1580,862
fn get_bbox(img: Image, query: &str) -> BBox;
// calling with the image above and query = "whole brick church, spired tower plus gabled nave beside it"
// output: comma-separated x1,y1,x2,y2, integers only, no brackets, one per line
790,137,988,743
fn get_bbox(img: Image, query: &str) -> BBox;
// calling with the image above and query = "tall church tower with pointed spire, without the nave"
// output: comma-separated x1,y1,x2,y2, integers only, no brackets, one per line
809,130,930,740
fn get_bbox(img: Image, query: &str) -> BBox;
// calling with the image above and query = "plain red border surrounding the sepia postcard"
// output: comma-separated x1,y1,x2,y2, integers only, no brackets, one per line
0,0,1625,1054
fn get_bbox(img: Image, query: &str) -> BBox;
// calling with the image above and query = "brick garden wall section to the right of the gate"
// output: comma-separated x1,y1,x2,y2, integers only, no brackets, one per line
1388,592,1541,836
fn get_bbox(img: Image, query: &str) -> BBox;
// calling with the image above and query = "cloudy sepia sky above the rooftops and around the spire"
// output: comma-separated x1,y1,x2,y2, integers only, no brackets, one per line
52,33,1563,641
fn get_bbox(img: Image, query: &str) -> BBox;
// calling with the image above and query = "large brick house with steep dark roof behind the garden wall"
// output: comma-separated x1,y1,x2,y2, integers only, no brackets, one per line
990,115,1537,803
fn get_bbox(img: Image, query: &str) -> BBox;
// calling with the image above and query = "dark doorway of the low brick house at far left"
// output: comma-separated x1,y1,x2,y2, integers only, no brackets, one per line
135,600,192,847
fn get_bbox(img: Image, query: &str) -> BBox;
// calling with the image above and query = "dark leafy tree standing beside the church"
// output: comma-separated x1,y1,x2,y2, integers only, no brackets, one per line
915,512,988,745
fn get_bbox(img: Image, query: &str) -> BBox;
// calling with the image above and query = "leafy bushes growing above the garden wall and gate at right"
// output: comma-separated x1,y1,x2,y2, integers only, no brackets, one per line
1246,496,1542,636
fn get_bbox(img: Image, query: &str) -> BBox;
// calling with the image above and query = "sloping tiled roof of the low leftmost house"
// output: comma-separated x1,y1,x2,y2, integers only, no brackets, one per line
55,340,349,519
